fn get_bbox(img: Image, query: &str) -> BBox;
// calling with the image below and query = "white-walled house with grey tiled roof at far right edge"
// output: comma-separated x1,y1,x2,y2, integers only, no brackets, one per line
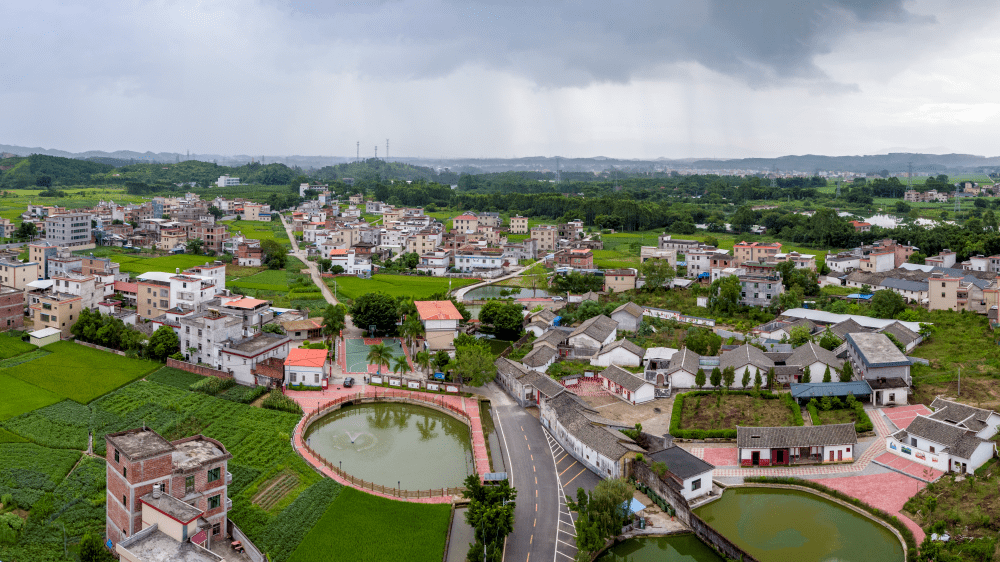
885,416,996,474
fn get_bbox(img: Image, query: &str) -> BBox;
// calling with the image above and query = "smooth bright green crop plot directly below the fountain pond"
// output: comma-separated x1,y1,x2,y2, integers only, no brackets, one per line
289,488,450,562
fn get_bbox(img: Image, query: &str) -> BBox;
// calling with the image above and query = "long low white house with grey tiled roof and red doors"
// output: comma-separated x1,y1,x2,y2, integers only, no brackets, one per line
736,423,858,466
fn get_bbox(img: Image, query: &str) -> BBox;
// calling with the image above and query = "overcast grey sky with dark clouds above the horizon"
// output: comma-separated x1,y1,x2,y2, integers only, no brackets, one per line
0,0,1000,159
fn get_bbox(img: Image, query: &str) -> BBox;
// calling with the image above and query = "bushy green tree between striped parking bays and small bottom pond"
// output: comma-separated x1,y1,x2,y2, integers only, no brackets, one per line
566,478,635,560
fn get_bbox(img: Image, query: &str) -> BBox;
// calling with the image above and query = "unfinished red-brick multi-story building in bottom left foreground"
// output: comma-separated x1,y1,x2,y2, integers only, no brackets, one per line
105,428,233,552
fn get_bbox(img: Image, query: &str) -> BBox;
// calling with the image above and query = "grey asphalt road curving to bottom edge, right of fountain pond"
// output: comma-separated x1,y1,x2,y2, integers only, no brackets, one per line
493,400,562,562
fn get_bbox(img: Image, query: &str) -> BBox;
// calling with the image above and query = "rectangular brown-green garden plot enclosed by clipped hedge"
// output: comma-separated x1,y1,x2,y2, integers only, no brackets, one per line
680,392,795,429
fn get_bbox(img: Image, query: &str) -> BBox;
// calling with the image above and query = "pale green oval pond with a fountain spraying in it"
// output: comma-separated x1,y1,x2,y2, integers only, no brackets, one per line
305,403,475,490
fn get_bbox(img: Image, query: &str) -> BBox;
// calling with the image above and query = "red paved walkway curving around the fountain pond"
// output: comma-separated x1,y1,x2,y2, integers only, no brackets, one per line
285,385,490,503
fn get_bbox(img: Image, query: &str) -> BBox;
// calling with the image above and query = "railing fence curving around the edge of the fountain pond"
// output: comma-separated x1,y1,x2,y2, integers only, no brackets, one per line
299,388,472,498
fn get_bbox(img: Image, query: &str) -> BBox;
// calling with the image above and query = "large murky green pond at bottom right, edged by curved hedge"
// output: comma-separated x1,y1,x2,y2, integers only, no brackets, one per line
695,488,903,562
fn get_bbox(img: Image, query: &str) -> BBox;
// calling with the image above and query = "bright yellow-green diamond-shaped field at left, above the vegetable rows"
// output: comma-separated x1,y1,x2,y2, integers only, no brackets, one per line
0,341,160,400
